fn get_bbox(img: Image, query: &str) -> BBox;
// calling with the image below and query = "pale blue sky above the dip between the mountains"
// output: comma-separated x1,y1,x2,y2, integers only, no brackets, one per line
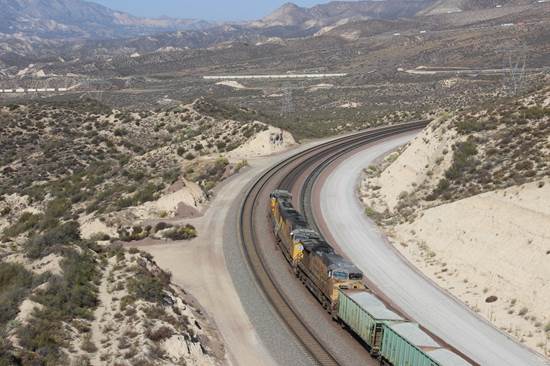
88,0,327,21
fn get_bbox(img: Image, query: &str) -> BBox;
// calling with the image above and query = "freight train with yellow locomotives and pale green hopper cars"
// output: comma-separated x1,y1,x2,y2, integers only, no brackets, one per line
270,190,472,366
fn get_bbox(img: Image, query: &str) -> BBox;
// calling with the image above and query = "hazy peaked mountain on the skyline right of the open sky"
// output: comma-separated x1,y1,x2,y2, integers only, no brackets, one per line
251,0,435,29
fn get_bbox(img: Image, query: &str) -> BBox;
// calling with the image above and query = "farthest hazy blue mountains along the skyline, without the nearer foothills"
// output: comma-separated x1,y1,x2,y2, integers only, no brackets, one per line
0,0,534,40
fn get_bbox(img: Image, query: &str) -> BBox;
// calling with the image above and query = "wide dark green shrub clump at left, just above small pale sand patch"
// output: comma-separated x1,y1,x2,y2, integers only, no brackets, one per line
24,221,81,258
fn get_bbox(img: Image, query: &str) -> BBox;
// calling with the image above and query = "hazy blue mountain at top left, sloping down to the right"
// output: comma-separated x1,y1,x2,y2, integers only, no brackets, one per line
0,0,212,39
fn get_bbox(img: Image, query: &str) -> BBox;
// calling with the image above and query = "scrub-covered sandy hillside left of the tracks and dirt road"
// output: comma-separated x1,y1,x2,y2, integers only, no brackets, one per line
0,99,293,365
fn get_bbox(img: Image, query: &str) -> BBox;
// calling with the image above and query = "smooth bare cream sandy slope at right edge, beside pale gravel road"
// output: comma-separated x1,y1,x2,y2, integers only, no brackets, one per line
393,180,550,356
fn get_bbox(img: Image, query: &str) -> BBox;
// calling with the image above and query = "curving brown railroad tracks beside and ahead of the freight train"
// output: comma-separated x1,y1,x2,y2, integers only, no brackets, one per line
239,121,427,366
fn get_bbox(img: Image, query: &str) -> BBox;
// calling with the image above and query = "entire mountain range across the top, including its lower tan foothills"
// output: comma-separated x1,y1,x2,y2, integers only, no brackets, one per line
0,0,546,64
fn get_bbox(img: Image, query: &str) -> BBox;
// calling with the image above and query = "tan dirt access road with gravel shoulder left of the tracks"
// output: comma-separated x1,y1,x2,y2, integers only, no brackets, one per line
139,146,322,366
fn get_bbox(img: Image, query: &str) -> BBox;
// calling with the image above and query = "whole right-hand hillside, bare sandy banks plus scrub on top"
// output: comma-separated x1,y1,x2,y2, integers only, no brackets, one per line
361,84,550,356
